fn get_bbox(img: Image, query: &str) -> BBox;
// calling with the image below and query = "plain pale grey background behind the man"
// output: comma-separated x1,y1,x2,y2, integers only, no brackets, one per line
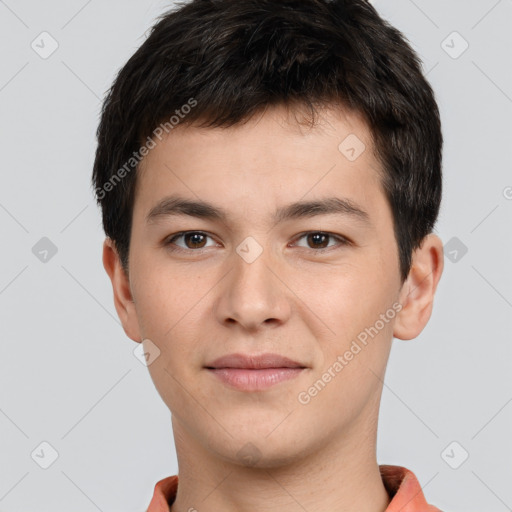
0,0,512,512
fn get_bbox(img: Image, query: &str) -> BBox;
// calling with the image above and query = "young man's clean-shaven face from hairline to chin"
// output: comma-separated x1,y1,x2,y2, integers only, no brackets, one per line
103,107,440,467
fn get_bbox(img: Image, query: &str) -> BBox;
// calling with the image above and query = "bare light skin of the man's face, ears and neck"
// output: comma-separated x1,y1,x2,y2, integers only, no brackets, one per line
103,107,443,512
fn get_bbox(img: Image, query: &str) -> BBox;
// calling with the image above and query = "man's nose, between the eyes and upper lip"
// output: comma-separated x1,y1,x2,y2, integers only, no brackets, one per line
216,240,293,331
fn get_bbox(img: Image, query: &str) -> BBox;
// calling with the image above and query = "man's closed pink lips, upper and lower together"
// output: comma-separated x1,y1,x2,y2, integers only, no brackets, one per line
205,353,306,391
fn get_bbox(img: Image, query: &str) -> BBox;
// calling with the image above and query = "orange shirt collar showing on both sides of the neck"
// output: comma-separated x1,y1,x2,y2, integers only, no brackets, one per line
146,466,441,512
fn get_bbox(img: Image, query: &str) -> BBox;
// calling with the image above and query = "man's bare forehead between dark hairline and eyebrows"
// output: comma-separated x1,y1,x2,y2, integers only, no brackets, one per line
134,107,382,226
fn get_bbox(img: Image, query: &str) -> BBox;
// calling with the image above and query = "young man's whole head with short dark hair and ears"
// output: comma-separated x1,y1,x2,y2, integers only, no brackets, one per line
93,0,443,465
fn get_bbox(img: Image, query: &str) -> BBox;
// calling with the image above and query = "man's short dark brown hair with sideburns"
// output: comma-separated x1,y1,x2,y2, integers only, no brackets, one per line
92,0,443,280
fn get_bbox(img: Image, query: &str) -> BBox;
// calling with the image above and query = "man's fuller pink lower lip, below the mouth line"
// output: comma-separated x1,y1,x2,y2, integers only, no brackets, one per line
209,368,304,391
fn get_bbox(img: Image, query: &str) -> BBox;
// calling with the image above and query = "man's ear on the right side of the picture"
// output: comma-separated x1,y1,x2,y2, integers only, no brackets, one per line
393,234,444,340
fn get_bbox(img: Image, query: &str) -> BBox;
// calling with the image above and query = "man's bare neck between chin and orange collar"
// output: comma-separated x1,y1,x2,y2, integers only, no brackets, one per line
171,418,389,512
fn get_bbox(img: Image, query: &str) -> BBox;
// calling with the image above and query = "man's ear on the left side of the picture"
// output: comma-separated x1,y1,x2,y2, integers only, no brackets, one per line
103,237,142,342
